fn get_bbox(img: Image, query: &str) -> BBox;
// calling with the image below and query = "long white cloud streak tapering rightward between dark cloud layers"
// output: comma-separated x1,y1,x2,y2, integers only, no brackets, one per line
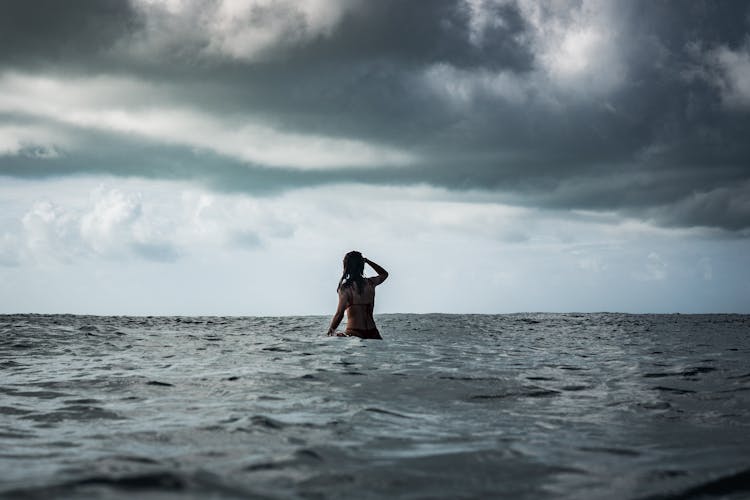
0,73,416,170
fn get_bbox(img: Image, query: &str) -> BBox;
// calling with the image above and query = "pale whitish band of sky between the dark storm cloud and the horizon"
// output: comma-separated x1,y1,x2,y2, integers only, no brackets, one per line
0,177,750,314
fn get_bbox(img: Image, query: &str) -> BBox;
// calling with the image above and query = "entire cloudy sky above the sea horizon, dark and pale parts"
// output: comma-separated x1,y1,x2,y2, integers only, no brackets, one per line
0,0,750,315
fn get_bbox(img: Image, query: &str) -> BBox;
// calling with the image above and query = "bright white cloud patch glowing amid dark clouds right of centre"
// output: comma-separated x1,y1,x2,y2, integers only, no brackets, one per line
422,0,627,107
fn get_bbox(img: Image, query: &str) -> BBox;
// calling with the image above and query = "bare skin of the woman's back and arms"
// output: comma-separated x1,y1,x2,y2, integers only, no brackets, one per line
327,258,388,337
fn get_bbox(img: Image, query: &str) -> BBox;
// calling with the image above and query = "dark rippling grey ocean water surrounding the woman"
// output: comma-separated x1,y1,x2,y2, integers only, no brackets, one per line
0,314,750,500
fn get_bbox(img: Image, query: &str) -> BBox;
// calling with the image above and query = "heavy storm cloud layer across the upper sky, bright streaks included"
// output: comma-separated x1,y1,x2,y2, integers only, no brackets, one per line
0,0,750,232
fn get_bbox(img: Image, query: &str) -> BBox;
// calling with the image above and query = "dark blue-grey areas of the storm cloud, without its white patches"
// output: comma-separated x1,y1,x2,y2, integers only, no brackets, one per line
0,0,750,231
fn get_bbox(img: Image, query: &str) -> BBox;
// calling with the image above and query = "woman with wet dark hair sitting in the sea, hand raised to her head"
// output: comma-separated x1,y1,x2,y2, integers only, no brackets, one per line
328,251,388,339
